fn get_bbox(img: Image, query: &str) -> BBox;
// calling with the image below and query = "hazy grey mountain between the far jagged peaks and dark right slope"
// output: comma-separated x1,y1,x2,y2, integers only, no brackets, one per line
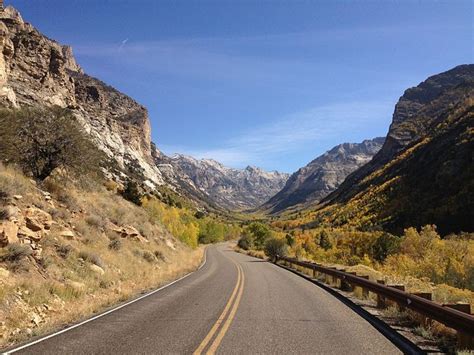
262,138,384,213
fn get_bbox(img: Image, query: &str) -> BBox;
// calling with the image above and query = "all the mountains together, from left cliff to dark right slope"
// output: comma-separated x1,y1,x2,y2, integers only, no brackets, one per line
0,6,474,233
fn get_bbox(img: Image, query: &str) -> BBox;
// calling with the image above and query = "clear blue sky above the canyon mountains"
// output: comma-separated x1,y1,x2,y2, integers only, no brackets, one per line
5,0,473,172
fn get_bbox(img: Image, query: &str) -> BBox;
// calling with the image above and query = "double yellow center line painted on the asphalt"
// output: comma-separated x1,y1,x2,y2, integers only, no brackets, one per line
193,260,245,355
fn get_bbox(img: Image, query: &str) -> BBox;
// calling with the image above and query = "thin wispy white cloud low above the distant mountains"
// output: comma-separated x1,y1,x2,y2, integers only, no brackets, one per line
162,102,393,171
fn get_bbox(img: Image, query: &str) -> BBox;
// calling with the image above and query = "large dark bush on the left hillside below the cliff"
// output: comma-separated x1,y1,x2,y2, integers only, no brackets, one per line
0,107,104,180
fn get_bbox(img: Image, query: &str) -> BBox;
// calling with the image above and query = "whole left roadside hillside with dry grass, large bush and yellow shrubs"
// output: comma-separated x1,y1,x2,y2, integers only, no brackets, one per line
0,108,241,347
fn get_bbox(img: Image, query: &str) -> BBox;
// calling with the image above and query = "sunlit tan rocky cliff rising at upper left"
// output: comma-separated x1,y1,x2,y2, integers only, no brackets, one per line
0,6,164,185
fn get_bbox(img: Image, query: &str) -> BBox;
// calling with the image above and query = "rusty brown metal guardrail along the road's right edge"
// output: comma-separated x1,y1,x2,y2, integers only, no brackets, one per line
276,256,474,337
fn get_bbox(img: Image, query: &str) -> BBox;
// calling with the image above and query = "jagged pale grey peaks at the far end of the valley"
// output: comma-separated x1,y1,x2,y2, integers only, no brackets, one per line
163,155,289,210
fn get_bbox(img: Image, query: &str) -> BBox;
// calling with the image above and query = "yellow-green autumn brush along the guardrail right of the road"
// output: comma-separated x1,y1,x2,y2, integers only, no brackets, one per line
238,216,474,352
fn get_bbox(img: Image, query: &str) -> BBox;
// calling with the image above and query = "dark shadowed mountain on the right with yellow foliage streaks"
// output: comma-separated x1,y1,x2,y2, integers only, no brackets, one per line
319,64,474,234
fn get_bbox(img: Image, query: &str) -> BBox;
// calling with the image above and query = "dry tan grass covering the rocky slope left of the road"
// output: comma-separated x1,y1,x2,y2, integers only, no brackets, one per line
0,166,203,348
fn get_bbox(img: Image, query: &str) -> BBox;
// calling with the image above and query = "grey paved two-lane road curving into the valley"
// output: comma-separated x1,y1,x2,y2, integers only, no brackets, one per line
8,245,400,354
